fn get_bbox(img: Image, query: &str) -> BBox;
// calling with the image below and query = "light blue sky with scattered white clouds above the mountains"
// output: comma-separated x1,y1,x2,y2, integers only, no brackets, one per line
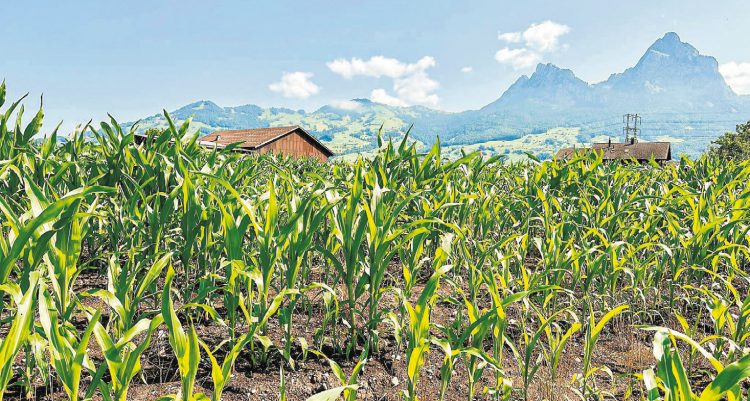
0,0,750,127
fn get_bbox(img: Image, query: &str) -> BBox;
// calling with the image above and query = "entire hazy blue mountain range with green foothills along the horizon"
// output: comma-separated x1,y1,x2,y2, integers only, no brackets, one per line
135,32,750,154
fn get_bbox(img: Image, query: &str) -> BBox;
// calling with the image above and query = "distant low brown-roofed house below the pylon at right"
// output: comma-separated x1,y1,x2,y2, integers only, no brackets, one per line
557,141,672,163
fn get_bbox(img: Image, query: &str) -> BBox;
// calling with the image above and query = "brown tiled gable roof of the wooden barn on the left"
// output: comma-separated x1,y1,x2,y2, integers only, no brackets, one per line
200,125,333,156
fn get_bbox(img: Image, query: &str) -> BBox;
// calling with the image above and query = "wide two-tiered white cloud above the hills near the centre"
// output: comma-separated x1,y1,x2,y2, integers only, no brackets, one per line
326,56,440,107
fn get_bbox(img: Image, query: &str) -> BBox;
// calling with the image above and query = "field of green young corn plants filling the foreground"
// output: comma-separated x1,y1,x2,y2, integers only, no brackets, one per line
0,79,750,401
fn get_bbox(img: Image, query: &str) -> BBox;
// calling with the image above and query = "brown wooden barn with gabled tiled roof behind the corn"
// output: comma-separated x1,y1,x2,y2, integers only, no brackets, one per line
198,125,333,161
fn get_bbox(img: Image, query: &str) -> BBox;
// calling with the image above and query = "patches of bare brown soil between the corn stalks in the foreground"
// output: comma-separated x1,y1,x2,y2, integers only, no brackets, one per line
5,266,710,401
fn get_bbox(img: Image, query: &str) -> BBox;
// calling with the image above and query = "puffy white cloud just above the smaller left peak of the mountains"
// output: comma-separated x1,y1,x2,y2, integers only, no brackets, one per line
495,21,570,69
